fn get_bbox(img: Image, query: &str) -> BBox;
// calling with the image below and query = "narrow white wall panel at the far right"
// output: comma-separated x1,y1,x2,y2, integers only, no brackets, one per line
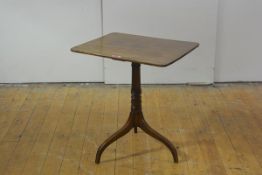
215,0,262,82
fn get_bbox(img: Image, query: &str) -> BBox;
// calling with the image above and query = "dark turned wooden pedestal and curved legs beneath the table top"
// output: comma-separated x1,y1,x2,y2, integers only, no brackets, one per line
95,63,178,164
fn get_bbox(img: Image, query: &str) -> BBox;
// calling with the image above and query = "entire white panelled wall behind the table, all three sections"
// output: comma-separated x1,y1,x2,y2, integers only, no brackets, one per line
0,0,262,83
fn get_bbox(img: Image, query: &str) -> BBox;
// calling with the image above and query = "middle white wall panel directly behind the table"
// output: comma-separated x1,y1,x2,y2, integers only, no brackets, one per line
103,0,217,83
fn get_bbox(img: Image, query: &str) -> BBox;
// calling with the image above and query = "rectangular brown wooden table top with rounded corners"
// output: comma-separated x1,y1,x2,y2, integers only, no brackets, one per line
71,33,199,66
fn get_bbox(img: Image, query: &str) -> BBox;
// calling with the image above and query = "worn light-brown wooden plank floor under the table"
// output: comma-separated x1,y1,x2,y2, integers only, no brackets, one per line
0,84,262,175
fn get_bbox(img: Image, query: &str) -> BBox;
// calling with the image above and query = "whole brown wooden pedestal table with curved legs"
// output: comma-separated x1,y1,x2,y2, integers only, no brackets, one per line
71,33,199,164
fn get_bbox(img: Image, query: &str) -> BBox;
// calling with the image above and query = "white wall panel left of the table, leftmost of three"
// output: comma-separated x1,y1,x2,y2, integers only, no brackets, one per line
0,0,103,83
